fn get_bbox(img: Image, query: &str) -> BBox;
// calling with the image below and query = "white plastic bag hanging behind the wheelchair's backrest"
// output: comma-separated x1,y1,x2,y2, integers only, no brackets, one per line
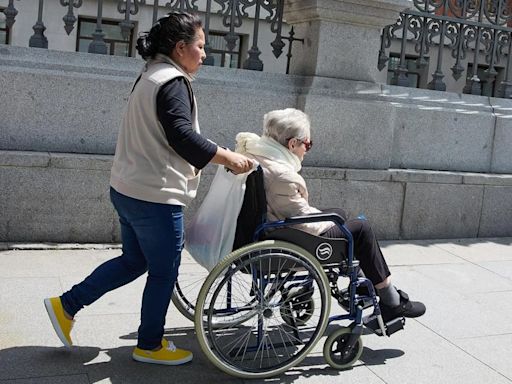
185,165,255,271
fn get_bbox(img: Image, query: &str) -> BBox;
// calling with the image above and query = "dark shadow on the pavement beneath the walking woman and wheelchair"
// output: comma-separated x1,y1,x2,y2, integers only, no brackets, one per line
0,327,404,384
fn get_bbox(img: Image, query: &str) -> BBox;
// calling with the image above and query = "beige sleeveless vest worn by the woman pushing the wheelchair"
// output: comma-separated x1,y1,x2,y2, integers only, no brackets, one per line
110,60,200,206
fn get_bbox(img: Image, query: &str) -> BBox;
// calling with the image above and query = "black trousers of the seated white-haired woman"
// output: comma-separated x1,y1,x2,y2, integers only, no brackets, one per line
321,208,391,285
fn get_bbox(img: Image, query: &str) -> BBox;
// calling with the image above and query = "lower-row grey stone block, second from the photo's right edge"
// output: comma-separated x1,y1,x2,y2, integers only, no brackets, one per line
401,183,484,239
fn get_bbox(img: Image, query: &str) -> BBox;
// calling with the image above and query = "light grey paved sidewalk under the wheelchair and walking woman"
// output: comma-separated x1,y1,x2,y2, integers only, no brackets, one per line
0,238,512,384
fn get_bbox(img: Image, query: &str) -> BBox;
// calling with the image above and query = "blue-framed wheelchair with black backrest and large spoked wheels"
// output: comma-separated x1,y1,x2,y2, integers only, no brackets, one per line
173,168,405,379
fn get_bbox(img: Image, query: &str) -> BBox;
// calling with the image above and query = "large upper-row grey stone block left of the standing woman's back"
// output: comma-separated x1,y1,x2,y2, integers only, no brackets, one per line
0,67,131,154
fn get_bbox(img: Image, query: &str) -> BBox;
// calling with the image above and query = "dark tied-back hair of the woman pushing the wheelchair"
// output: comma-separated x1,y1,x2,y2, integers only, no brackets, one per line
137,12,203,60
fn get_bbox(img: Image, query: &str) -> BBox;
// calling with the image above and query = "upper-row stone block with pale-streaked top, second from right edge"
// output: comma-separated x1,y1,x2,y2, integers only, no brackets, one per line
383,85,495,172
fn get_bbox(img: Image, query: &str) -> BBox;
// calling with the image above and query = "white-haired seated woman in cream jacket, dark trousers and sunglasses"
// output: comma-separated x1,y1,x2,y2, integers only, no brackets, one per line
236,108,425,322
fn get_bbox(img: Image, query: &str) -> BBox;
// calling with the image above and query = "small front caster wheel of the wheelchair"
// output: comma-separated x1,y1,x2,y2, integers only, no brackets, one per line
324,327,363,370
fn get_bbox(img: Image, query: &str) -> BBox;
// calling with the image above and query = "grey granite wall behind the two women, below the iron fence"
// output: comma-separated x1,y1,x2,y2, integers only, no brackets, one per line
0,45,512,242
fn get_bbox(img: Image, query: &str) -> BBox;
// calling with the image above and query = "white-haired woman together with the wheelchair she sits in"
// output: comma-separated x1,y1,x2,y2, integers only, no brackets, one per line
175,108,425,378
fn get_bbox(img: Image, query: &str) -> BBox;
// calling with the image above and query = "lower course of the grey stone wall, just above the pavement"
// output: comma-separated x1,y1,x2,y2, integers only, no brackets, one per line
0,151,512,243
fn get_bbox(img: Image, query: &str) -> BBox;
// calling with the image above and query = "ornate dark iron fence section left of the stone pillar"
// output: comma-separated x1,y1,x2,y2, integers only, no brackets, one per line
3,0,303,73
